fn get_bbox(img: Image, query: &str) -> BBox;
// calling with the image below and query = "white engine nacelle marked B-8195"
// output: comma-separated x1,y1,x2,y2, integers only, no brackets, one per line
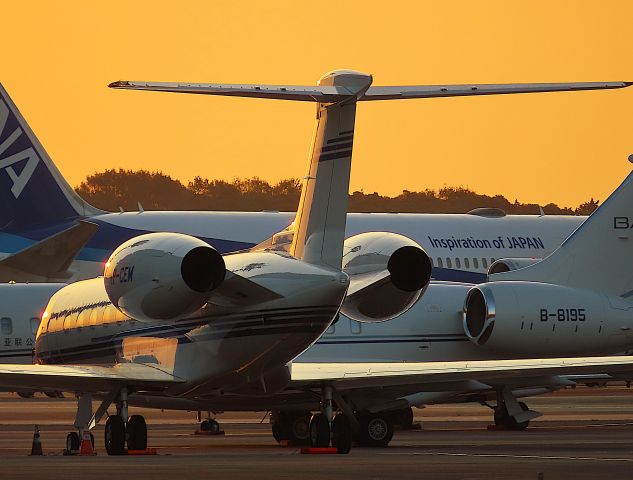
463,281,633,357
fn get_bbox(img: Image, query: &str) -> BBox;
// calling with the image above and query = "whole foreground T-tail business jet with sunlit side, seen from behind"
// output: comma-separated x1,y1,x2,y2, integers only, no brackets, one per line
0,71,633,453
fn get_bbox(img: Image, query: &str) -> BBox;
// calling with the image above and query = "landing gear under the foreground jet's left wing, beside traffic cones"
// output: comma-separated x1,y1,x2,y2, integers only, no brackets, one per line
66,387,147,455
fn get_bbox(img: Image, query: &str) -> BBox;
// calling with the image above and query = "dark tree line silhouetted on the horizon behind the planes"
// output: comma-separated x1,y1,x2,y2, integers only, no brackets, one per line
76,169,598,215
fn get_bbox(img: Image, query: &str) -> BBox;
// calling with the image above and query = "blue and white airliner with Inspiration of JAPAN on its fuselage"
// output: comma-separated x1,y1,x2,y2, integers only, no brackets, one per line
0,82,628,282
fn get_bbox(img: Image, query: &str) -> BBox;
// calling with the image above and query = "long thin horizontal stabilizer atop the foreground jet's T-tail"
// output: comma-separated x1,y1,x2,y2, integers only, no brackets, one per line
109,81,633,103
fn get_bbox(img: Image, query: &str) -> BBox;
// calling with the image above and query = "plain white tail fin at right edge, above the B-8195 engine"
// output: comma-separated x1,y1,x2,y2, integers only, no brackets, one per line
489,169,633,298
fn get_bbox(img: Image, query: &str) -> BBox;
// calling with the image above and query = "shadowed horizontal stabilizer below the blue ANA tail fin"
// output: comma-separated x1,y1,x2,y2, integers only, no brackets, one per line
0,221,99,282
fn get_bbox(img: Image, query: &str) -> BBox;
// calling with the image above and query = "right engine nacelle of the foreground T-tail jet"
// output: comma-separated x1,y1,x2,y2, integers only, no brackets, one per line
341,232,432,322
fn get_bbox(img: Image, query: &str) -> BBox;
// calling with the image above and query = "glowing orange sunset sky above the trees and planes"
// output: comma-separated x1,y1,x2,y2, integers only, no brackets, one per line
0,0,633,206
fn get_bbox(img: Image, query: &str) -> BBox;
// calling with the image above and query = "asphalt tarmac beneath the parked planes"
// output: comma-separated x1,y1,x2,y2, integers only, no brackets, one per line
0,387,633,480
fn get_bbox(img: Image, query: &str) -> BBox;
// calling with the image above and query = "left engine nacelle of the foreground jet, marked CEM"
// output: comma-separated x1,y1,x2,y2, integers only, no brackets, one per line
103,233,226,321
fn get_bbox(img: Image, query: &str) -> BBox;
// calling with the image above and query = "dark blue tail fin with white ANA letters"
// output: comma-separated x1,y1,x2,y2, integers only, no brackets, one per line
0,85,103,230
